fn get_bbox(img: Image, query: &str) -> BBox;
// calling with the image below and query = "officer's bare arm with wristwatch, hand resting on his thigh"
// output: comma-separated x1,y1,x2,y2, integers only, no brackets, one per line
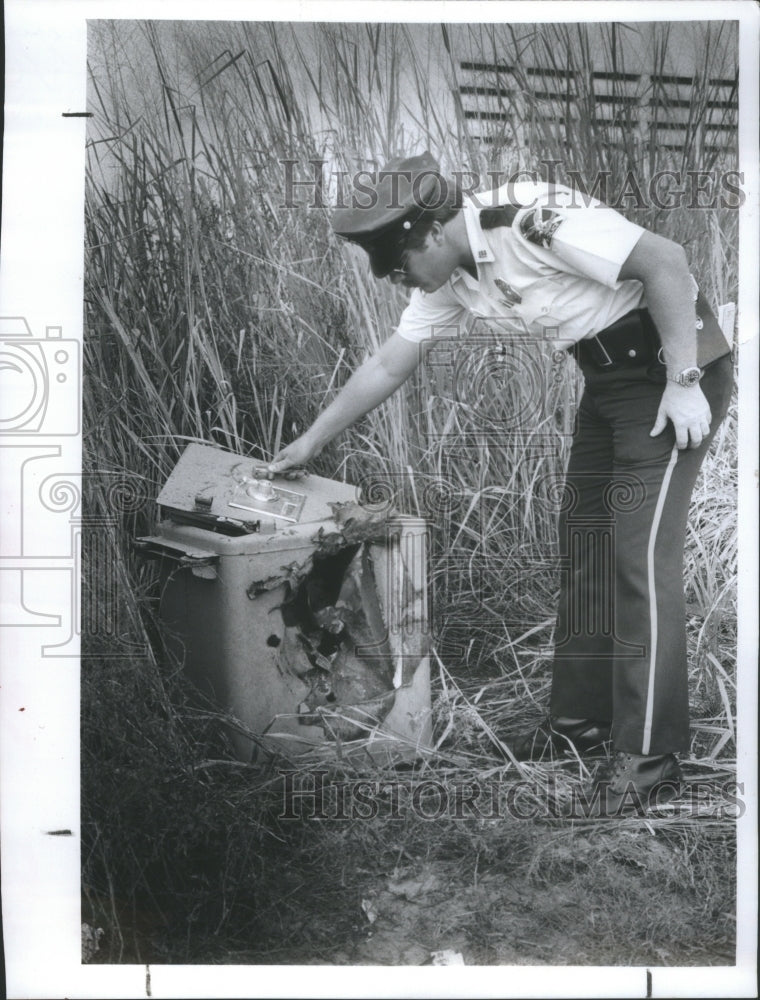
619,232,711,448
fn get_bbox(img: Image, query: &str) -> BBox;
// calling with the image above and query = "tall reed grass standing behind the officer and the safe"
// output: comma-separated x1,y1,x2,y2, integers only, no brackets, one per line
83,21,737,960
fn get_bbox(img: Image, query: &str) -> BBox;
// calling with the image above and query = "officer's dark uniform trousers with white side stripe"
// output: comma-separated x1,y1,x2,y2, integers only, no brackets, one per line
551,355,733,754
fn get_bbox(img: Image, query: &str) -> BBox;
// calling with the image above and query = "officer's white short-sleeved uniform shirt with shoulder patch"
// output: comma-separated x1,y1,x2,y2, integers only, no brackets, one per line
397,182,646,348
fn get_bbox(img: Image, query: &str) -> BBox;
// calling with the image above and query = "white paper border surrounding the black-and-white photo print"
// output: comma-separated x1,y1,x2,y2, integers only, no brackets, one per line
0,0,760,998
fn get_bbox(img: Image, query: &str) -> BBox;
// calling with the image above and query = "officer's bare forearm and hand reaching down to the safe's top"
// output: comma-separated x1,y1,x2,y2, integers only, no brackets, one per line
268,333,421,473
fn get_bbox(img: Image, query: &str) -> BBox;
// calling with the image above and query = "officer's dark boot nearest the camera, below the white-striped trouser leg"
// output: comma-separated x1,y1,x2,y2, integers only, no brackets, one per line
572,750,681,819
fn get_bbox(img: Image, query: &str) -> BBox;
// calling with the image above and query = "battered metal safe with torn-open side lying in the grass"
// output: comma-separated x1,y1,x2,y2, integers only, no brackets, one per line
136,444,431,761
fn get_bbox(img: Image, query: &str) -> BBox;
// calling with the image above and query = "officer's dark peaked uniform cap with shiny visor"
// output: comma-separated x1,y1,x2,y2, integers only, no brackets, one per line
332,152,447,278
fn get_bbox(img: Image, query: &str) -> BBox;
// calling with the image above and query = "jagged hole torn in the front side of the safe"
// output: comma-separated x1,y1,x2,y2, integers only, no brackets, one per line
280,543,396,740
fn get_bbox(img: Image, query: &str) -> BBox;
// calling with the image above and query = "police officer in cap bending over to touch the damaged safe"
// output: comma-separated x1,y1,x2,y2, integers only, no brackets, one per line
269,154,732,815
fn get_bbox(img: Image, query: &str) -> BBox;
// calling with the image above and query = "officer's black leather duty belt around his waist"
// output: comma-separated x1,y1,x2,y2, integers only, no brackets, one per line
575,292,731,375
